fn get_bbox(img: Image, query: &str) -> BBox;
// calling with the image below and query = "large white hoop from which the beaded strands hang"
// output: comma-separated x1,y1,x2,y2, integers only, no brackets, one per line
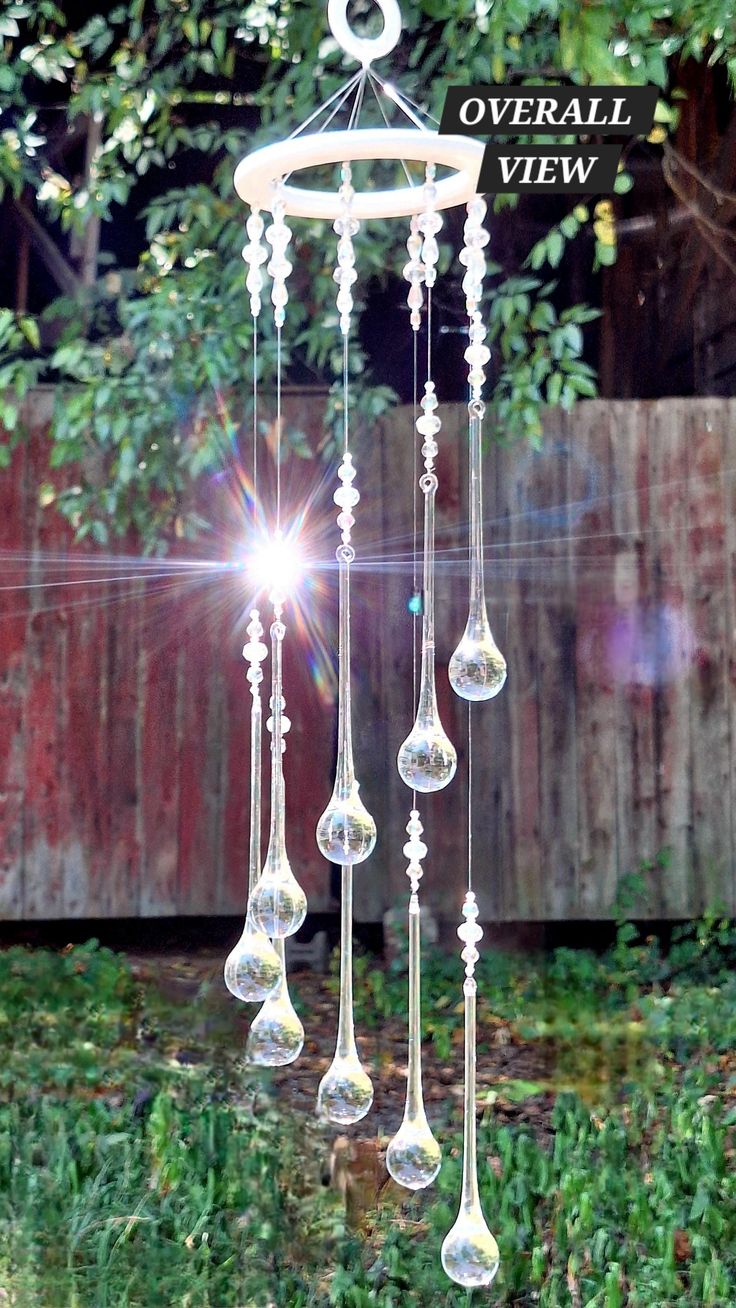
234,127,484,221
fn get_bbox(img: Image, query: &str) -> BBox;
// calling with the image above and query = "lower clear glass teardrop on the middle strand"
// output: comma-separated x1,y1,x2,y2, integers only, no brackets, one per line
316,863,373,1126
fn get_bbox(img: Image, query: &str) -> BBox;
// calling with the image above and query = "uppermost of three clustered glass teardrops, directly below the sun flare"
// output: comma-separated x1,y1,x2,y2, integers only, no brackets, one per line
251,619,307,939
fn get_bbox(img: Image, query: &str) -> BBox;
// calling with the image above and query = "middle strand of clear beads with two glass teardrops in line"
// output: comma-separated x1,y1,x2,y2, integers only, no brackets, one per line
316,164,375,1126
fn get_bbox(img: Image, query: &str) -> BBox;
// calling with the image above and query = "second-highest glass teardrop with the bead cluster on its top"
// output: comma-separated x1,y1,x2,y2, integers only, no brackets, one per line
396,392,458,794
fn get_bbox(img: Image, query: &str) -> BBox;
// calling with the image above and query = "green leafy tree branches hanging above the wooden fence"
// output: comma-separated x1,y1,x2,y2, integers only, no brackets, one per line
0,0,736,549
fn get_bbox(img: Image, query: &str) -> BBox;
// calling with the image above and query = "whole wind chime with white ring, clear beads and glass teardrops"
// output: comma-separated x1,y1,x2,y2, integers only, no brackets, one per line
225,0,506,1287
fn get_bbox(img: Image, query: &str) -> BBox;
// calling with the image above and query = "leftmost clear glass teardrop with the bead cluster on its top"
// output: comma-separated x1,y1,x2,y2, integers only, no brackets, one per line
225,608,281,1003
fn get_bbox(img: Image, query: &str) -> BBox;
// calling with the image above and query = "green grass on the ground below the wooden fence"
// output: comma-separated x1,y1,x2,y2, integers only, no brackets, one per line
0,921,736,1308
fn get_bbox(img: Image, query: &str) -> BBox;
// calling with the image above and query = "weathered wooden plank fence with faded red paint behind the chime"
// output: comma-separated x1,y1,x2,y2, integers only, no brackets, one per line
0,395,736,921
